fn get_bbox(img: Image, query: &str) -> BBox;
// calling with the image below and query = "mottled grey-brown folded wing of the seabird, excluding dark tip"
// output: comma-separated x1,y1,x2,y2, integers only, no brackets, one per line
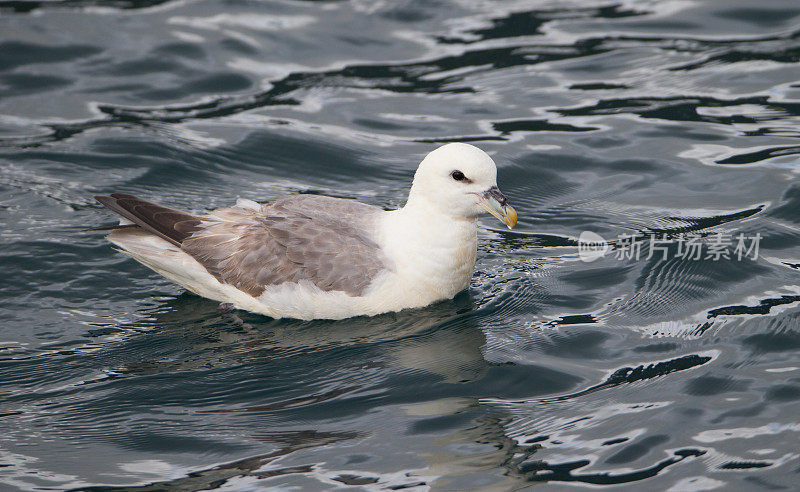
181,195,394,296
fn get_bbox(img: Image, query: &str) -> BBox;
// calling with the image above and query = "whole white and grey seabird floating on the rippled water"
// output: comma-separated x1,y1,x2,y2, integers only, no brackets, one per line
95,143,517,319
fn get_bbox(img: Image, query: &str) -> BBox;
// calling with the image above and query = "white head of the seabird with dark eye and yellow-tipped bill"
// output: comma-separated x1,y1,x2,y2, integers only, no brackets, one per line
406,143,517,229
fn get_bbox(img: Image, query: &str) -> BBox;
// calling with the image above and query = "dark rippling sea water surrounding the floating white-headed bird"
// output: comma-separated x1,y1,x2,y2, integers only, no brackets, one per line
0,0,800,491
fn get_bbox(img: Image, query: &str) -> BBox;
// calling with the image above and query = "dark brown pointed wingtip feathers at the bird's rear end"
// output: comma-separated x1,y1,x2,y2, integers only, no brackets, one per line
94,193,201,246
